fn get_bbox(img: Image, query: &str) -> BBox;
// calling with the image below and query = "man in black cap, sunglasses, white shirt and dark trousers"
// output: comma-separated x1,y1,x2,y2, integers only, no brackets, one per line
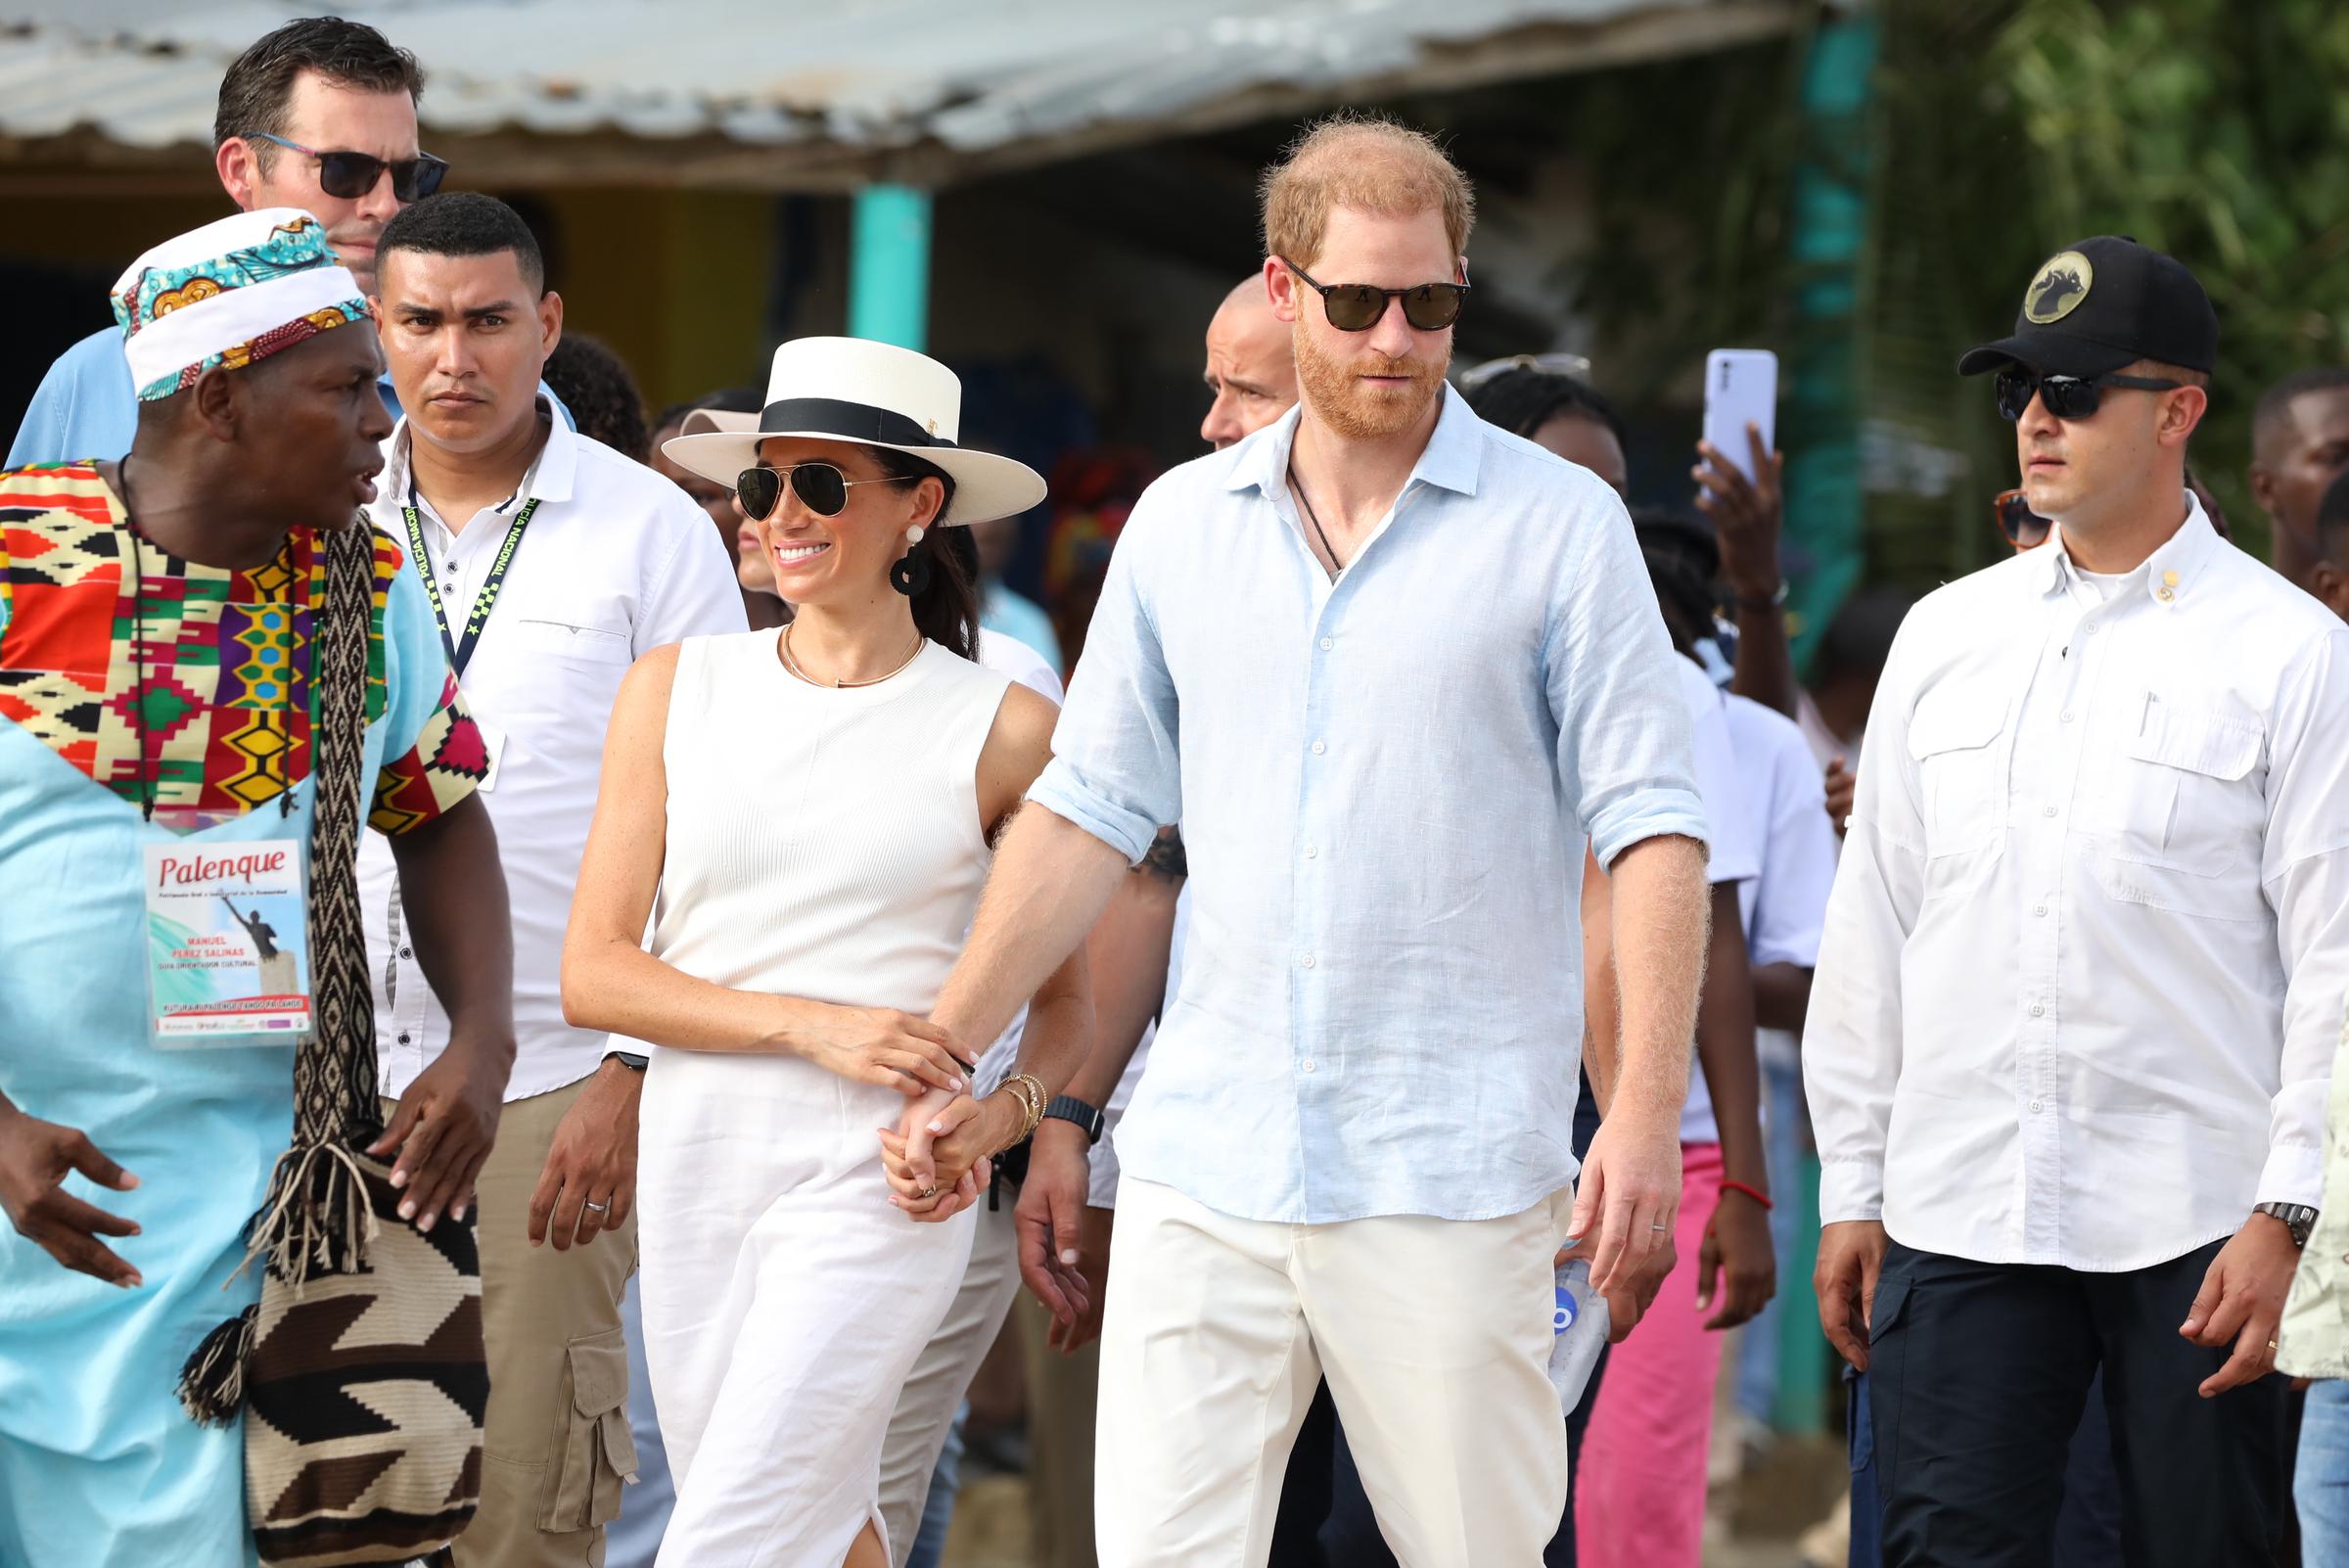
1804,237,2349,1568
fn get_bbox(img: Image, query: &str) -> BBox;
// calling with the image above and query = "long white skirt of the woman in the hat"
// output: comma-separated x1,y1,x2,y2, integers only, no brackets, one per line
636,1051,973,1568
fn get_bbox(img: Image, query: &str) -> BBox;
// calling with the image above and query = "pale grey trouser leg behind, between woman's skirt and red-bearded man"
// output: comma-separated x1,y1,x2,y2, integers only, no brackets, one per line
881,1190,1020,1568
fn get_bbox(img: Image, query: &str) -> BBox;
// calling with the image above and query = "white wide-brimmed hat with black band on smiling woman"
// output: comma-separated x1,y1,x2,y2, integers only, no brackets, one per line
660,338,1045,526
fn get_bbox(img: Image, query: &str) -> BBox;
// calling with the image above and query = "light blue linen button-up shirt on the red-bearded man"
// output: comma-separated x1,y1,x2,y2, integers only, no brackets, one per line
1029,388,1708,1222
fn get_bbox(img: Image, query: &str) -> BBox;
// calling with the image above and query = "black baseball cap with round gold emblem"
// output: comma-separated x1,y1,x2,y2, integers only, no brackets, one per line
1957,235,2218,381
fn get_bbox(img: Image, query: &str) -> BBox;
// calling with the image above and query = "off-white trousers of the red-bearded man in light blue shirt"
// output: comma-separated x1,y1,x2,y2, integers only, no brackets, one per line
1094,1176,1572,1568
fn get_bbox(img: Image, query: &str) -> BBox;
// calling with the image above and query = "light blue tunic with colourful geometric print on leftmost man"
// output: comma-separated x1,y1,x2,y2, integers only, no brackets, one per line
0,465,482,1568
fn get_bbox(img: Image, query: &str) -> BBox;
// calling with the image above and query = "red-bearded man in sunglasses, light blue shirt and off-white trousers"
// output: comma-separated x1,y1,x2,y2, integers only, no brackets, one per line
909,115,1708,1568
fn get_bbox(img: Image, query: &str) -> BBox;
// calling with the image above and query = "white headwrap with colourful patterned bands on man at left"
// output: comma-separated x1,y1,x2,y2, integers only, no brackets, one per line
111,207,374,401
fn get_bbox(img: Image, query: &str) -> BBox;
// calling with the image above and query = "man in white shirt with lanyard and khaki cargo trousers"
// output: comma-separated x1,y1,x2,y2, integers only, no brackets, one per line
359,193,747,1568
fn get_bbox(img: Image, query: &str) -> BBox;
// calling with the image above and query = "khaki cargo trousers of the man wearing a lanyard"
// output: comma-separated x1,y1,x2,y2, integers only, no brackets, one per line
383,1080,636,1568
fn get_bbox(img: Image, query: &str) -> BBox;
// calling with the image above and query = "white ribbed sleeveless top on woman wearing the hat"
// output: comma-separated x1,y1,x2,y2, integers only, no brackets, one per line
648,631,1010,1014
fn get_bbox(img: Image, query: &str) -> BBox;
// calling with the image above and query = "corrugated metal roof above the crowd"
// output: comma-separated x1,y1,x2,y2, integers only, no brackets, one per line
0,0,1797,180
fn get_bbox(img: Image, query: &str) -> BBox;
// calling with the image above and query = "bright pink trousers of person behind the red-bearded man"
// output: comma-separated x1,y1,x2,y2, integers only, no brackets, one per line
1574,1143,1722,1568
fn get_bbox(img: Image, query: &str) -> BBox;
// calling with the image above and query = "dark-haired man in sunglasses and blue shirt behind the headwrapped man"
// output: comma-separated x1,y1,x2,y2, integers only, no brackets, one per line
7,17,571,467
